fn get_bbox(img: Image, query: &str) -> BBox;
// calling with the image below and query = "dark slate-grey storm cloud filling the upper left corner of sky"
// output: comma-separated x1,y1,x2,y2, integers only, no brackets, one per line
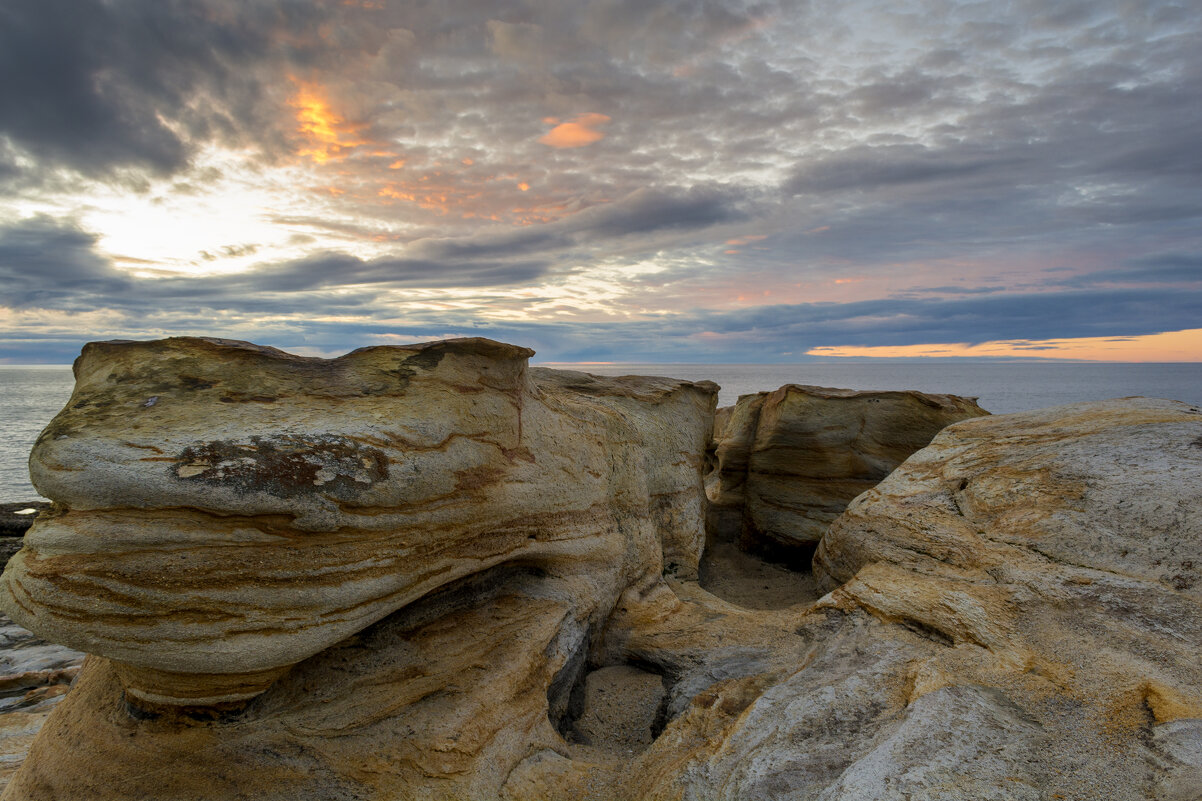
0,0,336,176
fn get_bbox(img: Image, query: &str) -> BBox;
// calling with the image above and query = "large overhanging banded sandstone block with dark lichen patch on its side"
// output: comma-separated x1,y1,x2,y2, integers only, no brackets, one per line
4,339,716,706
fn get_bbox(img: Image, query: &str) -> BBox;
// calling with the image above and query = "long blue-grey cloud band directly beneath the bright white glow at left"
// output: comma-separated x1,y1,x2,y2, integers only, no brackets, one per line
0,186,748,310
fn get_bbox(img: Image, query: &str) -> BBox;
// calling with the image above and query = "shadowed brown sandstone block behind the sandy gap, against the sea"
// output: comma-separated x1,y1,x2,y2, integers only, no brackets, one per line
708,384,988,558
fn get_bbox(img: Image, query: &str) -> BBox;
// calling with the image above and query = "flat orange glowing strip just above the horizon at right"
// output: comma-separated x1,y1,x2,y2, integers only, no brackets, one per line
805,328,1202,362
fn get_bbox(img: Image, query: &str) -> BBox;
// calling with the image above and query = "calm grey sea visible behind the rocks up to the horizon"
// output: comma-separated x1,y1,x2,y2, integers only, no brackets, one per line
0,362,1202,503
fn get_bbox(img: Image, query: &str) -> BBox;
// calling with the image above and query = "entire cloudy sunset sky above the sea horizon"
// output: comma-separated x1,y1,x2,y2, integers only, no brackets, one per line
0,0,1202,363
